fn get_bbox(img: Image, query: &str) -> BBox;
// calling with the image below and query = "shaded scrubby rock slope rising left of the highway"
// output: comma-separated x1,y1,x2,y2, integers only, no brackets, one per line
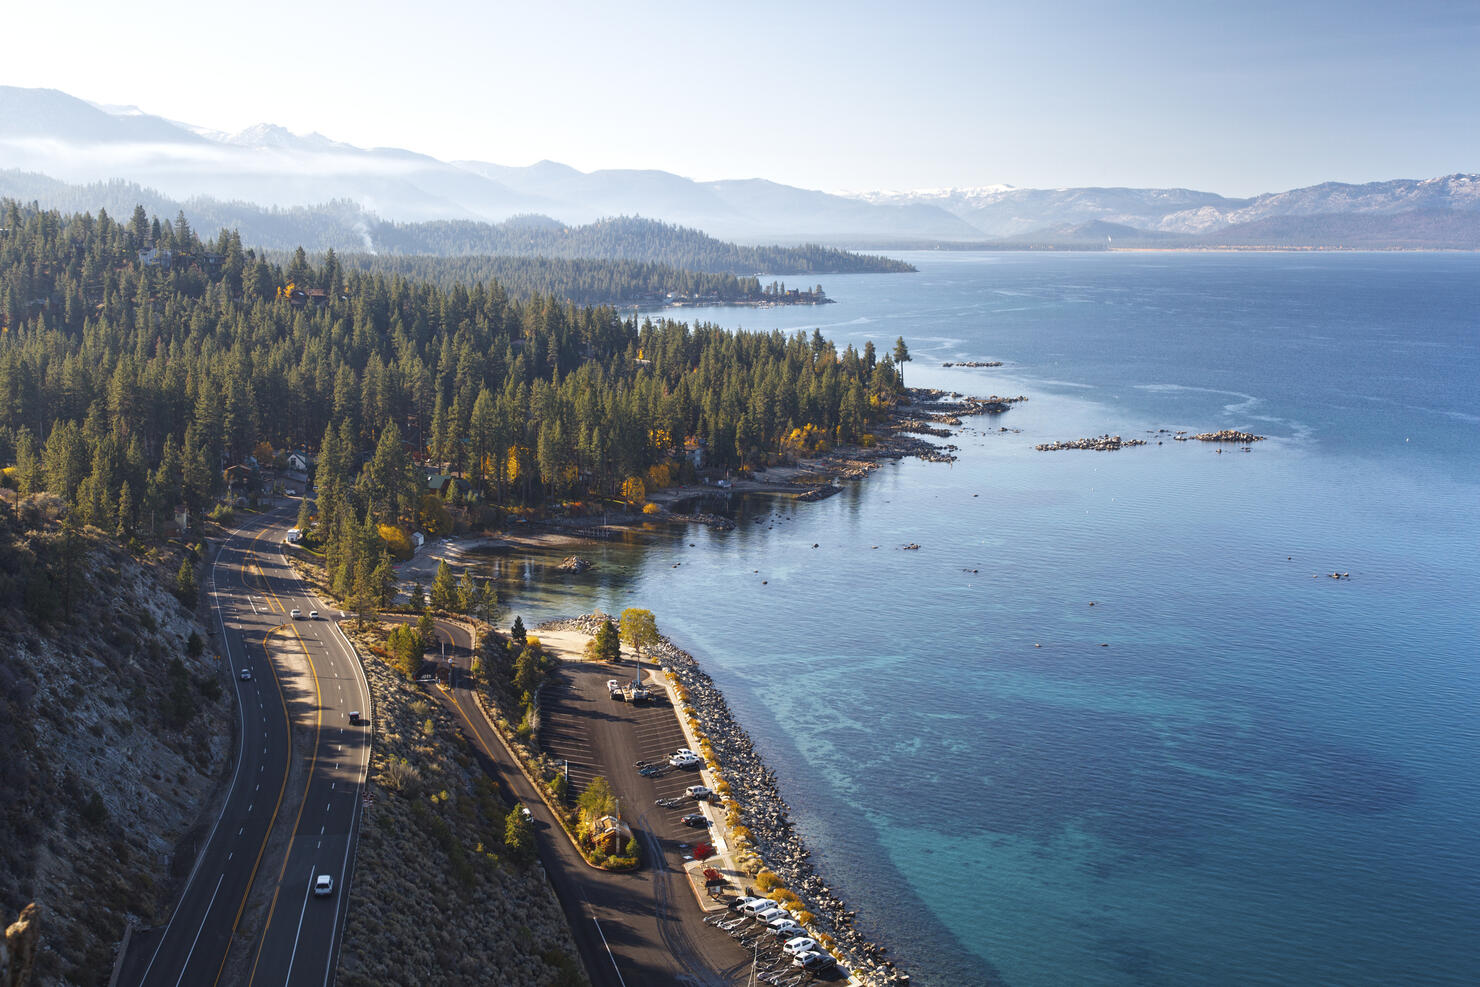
0,496,224,987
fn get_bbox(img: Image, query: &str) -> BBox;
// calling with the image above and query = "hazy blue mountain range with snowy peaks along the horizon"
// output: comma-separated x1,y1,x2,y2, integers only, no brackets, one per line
0,87,1480,249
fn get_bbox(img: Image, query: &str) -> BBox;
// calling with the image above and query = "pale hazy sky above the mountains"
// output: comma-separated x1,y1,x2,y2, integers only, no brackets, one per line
0,0,1480,195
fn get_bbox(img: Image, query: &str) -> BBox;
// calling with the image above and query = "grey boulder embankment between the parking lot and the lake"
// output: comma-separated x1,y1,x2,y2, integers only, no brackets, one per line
539,614,909,987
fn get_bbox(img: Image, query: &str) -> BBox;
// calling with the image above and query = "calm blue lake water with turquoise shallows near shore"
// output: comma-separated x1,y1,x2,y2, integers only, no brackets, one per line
479,253,1480,986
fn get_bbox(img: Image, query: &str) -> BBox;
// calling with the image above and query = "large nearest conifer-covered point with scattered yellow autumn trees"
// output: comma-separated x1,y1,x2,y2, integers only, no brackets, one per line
0,201,903,589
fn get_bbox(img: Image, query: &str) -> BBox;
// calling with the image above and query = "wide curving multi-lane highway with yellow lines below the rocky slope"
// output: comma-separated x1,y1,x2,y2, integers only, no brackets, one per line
118,508,371,987
